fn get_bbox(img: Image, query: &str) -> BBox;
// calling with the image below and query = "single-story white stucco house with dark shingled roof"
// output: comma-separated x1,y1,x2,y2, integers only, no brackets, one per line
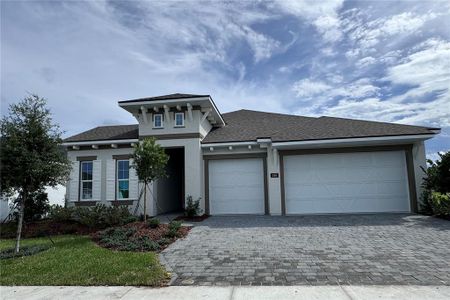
64,94,440,215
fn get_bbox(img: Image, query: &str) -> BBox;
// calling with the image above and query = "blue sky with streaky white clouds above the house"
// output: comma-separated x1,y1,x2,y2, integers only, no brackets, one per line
1,0,450,204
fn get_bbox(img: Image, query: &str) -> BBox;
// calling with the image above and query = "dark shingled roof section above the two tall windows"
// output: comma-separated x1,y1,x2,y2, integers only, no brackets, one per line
64,124,139,142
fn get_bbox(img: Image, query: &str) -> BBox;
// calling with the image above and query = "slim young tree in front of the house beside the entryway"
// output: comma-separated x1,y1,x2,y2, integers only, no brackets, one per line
132,138,169,222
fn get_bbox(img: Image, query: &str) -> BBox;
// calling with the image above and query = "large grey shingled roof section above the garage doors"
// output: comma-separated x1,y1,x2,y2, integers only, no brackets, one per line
202,110,436,143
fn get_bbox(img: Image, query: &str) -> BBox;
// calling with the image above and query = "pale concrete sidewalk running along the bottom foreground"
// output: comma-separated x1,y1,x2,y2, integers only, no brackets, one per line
0,286,450,300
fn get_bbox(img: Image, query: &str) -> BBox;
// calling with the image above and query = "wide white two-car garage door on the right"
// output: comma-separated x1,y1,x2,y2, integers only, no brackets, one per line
284,151,410,214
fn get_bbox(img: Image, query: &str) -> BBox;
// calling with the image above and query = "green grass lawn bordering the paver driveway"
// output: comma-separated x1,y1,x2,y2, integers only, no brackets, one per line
0,235,167,286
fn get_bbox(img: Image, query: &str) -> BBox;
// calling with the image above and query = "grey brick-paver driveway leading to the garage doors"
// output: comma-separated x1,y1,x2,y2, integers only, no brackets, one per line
161,214,450,285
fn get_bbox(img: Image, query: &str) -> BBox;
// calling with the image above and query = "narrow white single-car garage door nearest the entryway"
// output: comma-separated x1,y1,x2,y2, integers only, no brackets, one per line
209,158,264,215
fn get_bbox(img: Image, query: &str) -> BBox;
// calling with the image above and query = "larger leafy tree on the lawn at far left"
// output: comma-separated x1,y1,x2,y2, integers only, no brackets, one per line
0,95,70,253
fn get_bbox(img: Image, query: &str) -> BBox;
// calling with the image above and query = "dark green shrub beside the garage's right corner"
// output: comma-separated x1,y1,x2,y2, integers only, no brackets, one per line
420,151,450,217
